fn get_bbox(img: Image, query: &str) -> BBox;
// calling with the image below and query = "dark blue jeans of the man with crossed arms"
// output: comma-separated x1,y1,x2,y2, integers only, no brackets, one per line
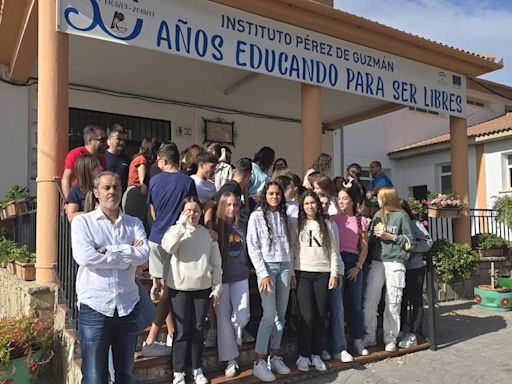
78,304,139,384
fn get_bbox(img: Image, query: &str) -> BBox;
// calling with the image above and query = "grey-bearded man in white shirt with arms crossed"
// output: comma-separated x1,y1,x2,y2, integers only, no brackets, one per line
71,172,149,384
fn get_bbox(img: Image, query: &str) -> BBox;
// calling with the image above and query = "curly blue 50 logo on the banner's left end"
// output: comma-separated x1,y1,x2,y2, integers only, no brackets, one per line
64,0,143,41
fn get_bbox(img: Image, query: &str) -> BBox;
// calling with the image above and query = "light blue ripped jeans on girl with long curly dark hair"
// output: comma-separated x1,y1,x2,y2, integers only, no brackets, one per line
255,262,292,355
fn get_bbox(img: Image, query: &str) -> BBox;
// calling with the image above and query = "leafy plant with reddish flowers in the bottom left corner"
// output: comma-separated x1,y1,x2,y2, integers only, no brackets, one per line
0,315,54,375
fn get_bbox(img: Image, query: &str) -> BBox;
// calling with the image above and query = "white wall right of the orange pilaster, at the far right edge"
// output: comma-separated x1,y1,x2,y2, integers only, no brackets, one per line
484,139,512,208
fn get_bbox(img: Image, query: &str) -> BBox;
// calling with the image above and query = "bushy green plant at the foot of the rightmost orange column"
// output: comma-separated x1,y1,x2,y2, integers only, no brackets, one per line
428,240,480,283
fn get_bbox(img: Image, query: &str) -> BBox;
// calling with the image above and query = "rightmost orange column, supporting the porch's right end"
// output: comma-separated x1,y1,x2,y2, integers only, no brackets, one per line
450,116,471,246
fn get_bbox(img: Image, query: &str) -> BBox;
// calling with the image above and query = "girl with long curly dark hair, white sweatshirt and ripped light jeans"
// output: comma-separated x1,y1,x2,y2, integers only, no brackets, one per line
247,181,293,381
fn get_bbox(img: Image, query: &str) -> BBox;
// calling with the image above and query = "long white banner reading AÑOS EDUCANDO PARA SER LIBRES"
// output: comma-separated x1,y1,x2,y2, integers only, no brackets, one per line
57,0,466,117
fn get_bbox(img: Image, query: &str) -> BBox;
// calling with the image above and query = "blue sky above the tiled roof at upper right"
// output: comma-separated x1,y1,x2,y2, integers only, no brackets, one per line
334,0,512,86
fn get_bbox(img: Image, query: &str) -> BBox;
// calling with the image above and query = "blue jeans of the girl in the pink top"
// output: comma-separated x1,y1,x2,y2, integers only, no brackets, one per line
341,252,364,339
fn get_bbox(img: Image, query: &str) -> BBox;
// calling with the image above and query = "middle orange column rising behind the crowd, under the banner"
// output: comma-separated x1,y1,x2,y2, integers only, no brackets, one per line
301,84,322,173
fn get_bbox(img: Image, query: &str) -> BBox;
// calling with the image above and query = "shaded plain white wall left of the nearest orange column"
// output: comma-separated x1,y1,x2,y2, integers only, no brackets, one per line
0,82,29,200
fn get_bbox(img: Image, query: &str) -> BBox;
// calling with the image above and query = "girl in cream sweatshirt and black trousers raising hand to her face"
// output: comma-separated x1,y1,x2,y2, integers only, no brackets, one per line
162,196,222,384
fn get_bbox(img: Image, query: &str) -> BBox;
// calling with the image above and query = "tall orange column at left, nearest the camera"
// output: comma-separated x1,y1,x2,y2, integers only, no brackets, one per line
36,0,69,283
